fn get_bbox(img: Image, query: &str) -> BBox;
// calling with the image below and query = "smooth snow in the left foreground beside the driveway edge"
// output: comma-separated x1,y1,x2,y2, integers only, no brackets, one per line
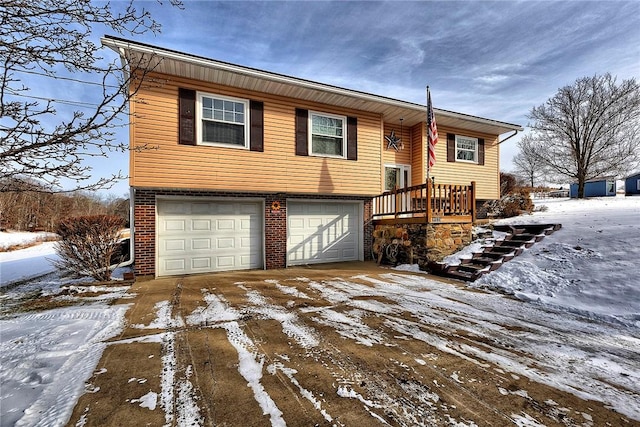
0,304,128,426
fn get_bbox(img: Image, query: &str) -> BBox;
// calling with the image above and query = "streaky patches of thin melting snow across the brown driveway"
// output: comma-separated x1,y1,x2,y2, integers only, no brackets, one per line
139,272,640,426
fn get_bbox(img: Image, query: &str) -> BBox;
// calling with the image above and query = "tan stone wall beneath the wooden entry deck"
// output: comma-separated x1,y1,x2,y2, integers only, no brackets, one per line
373,223,473,268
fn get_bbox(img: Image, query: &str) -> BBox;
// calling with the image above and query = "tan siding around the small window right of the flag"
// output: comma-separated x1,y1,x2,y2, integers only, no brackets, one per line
430,126,500,200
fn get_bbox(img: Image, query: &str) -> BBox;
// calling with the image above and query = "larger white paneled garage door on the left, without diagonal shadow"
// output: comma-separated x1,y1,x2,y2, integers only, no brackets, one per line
157,200,263,276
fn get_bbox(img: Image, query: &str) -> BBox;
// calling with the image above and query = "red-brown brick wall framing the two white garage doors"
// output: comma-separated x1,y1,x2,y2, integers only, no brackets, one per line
134,189,373,276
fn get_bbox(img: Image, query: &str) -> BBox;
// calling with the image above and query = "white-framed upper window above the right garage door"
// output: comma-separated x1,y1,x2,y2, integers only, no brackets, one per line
309,111,347,158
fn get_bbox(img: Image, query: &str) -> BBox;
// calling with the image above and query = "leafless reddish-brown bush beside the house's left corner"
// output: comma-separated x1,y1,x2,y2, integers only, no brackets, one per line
54,215,125,281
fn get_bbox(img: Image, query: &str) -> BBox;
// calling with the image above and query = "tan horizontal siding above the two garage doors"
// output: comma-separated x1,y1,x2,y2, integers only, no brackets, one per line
130,75,380,195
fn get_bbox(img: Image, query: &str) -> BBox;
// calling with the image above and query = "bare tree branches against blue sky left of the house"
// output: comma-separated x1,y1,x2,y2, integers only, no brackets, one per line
0,0,181,192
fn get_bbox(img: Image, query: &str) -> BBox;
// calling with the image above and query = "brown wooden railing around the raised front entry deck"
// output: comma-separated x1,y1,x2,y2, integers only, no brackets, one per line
373,182,476,223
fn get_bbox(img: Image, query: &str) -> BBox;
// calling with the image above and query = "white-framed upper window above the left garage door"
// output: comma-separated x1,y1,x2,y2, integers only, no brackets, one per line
196,93,249,148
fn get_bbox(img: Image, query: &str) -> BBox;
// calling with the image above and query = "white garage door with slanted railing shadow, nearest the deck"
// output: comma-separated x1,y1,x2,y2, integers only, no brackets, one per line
287,201,362,265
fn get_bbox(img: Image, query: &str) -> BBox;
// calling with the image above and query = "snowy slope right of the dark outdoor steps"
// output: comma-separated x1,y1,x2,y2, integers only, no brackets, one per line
473,196,640,327
